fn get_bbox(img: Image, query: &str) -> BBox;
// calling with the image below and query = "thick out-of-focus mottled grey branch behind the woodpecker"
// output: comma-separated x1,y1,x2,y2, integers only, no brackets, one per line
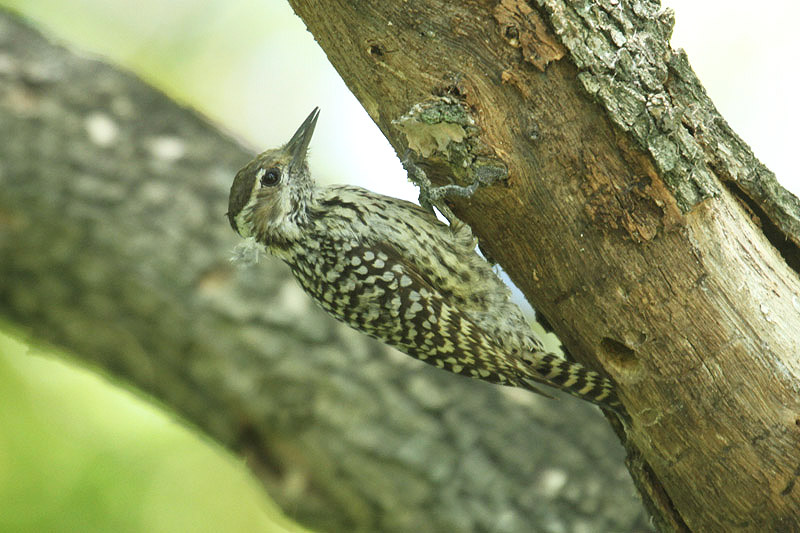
0,7,647,533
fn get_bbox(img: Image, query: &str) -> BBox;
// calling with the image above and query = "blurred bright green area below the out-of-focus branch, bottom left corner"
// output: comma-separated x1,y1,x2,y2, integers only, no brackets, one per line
0,325,310,533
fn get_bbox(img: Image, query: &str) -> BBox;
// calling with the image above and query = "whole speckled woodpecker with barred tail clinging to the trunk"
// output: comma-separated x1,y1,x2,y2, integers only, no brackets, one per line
227,108,623,413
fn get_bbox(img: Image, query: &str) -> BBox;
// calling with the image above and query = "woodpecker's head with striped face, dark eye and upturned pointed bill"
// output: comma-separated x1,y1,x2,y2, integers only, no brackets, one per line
227,107,319,240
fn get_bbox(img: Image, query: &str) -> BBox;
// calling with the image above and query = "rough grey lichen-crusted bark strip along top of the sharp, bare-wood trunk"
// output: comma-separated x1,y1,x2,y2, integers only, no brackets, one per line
537,0,720,211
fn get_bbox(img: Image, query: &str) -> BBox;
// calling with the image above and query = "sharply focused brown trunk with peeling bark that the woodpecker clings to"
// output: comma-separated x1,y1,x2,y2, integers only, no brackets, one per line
284,0,800,532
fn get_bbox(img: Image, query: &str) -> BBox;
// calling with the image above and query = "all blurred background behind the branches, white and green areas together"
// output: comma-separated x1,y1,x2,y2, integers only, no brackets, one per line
0,0,800,532
